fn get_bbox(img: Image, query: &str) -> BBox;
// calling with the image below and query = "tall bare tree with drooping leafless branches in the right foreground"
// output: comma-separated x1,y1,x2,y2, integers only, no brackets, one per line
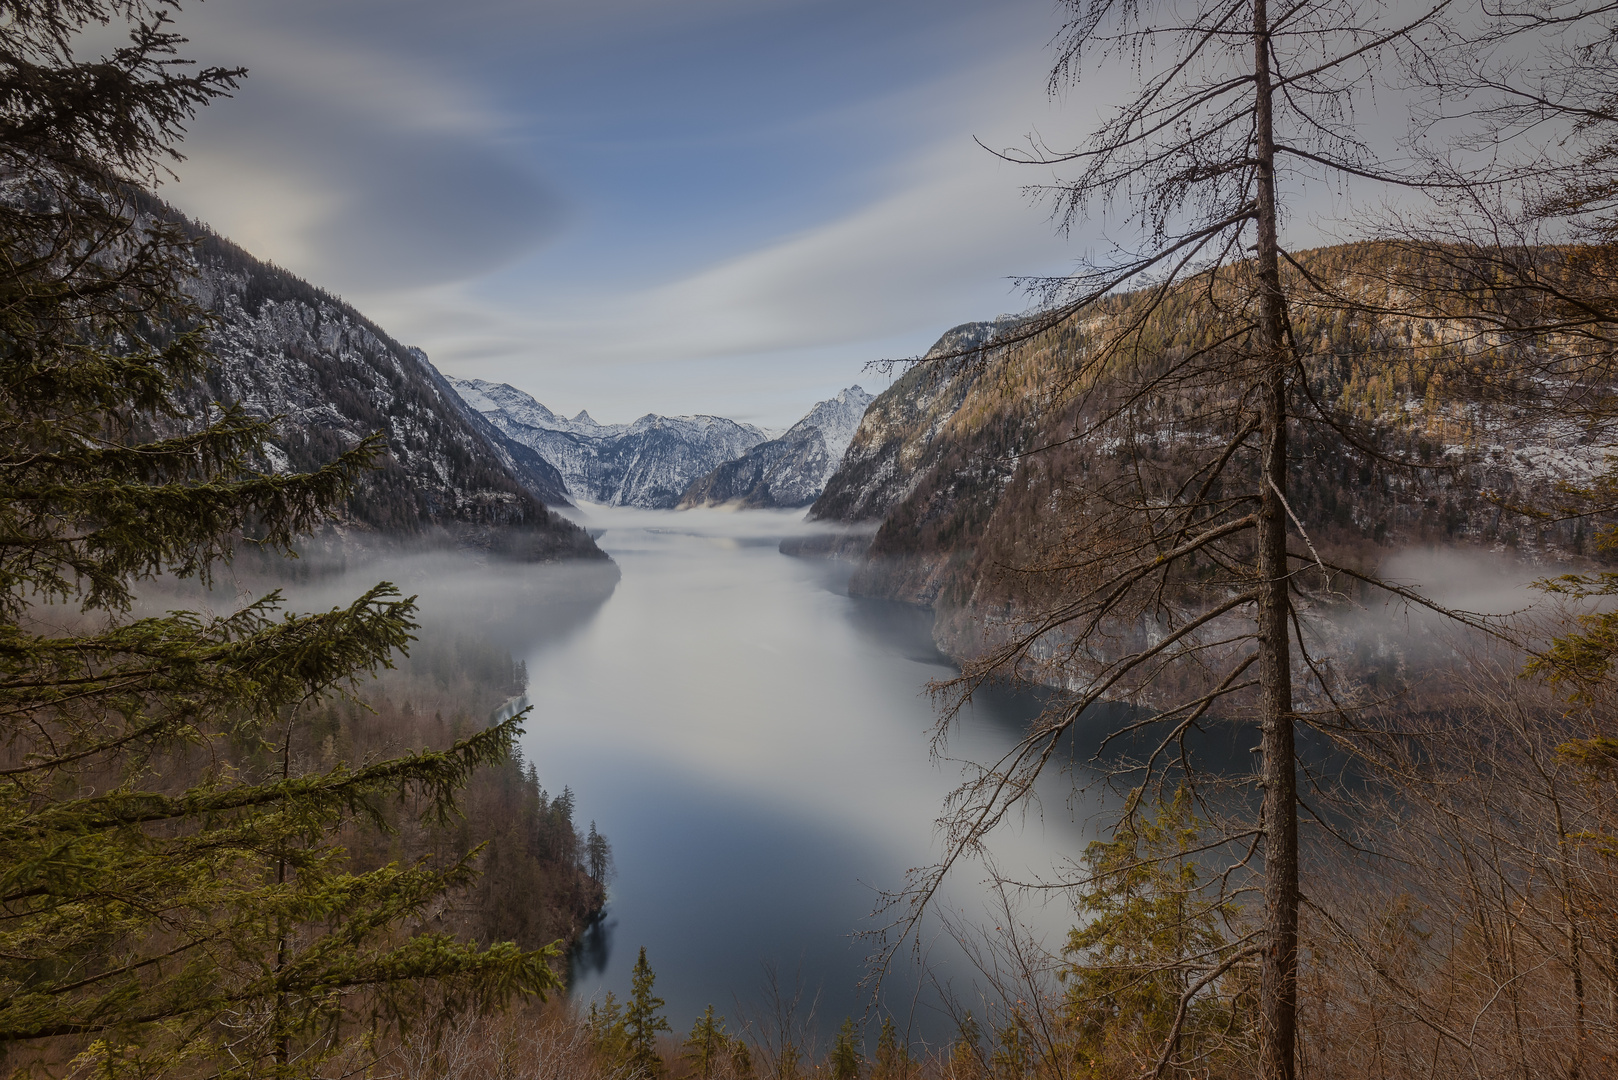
867,0,1520,1080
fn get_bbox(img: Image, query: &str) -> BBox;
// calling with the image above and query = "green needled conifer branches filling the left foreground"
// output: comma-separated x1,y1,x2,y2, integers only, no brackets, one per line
0,0,558,1077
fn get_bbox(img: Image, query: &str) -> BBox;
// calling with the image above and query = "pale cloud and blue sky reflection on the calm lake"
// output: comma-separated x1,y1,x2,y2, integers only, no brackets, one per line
524,507,1106,1038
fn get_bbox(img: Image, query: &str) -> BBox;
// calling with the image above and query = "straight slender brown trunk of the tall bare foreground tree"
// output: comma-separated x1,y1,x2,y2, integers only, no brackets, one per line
1252,0,1298,1080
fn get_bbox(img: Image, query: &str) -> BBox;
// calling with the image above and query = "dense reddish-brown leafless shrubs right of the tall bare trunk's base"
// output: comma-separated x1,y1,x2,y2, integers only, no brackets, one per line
1304,662,1618,1080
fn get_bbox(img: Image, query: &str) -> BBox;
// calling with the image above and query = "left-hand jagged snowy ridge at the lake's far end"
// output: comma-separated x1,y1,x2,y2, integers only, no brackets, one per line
450,379,770,510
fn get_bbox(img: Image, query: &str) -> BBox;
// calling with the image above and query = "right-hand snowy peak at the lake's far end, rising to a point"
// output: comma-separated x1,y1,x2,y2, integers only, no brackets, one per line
680,387,872,508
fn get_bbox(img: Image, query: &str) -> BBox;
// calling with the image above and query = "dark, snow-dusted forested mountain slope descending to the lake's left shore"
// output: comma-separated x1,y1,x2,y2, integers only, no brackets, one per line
167,199,605,559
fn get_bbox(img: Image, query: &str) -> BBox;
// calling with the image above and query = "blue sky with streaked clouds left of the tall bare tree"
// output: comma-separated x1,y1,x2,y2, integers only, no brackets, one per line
148,0,1097,426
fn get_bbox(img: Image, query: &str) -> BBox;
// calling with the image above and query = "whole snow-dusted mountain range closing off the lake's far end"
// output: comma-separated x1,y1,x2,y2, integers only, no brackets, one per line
450,379,870,510
